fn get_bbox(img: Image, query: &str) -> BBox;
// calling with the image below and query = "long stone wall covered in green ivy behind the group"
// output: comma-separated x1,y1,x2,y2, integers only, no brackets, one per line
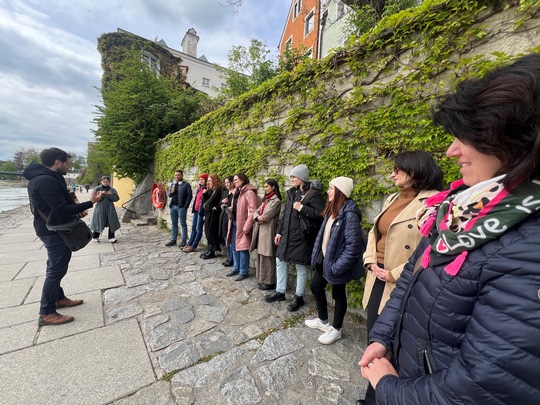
155,0,540,213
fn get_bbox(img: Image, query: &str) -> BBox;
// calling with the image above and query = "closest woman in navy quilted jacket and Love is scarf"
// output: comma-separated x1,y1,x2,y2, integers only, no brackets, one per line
359,54,540,404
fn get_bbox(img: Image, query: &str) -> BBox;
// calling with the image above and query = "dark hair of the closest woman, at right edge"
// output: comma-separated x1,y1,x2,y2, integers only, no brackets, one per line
433,54,540,190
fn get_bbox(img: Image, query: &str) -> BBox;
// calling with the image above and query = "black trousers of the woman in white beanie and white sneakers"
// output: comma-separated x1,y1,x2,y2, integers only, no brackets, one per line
311,270,347,330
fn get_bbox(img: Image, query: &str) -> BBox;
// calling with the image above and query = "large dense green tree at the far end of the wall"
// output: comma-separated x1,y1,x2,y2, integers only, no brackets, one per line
95,50,208,183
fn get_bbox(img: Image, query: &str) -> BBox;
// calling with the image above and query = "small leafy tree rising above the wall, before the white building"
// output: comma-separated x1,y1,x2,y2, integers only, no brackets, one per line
216,38,279,101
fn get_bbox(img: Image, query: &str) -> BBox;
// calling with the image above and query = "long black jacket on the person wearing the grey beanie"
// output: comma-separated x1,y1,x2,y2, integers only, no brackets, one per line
276,181,324,266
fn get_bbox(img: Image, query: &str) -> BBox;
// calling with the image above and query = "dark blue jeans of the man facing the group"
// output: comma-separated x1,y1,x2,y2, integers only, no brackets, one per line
39,234,71,315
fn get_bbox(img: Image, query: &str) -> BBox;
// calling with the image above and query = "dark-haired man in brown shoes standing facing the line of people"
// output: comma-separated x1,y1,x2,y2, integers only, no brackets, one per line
23,148,101,326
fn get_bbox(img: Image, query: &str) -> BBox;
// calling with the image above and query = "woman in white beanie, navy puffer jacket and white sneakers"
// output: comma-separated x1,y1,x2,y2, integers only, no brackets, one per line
305,177,366,345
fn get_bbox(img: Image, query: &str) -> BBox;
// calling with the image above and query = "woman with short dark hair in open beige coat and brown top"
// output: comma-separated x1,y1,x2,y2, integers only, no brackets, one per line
362,151,443,404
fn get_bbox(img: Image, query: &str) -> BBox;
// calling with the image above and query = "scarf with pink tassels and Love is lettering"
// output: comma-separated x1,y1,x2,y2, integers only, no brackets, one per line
418,175,540,276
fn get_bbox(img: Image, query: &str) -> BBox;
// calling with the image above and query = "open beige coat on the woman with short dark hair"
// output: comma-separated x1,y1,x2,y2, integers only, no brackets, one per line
362,190,438,314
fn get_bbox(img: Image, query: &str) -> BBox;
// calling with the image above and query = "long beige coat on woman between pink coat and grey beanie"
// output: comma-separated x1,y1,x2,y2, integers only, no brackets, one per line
249,194,281,256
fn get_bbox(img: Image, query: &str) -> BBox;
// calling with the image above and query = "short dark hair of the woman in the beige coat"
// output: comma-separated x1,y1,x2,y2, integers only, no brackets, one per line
393,150,443,191
